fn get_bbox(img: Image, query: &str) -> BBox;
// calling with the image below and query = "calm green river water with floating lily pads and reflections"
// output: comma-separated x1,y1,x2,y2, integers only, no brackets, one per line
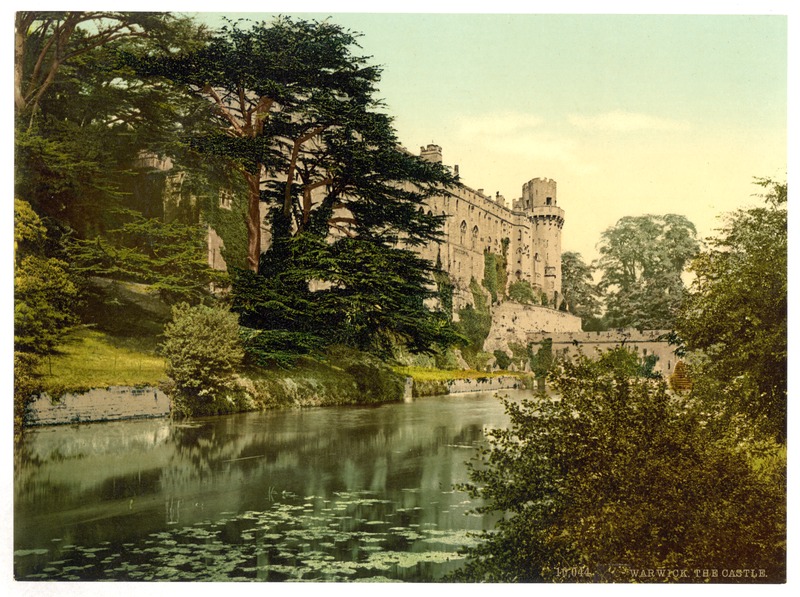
14,391,524,582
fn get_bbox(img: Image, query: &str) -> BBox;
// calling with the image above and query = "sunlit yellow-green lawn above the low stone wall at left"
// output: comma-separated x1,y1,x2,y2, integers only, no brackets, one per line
40,329,166,392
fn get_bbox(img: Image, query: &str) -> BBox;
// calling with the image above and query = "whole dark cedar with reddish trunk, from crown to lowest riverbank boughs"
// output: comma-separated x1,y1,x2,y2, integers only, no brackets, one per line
135,18,455,360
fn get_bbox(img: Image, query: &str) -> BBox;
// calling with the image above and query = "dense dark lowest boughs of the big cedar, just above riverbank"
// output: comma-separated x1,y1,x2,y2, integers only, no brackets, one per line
232,233,457,365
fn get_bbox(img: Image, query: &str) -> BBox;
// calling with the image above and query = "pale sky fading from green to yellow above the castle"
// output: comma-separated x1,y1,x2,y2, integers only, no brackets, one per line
194,2,788,262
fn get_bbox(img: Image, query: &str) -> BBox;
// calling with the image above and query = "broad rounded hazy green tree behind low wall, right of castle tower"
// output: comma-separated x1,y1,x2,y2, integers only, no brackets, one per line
596,214,699,329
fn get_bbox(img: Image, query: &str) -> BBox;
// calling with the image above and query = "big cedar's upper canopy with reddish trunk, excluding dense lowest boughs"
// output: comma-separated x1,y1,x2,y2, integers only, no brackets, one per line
126,17,452,271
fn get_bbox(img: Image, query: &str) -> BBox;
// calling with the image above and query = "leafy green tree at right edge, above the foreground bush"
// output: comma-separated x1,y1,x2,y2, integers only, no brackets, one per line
677,179,788,441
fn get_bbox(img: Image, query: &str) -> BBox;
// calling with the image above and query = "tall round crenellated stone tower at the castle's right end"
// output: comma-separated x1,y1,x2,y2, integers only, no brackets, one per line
517,178,564,308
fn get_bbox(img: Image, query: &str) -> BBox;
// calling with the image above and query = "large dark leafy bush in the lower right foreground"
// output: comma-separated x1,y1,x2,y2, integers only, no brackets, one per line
455,348,786,582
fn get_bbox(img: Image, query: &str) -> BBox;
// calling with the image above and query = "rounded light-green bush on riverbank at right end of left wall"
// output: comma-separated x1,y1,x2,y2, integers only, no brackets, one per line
161,303,244,415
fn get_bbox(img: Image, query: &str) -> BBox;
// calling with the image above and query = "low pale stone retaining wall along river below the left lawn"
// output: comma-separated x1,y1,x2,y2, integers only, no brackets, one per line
30,386,170,425
